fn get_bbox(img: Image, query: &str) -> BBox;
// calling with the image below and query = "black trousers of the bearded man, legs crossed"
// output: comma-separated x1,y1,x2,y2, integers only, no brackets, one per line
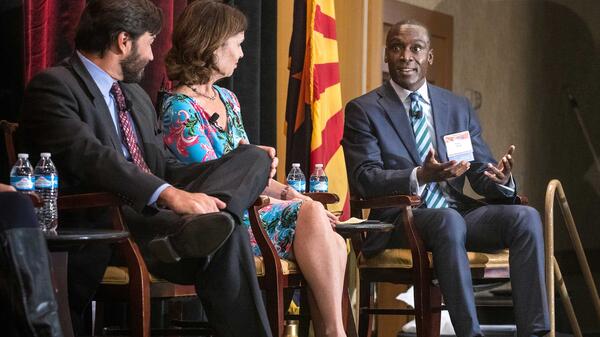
124,145,271,337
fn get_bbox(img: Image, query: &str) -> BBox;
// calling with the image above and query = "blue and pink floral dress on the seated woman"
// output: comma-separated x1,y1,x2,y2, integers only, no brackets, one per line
162,85,302,259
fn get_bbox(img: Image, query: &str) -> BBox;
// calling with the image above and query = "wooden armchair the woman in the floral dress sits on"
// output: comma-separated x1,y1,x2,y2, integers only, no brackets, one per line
250,193,353,337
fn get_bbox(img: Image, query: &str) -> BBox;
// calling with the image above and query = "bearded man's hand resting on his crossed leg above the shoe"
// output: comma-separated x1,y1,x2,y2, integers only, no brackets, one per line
157,186,227,215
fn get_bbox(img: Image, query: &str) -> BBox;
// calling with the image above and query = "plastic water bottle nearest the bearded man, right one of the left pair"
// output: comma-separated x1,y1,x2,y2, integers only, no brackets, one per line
33,152,58,231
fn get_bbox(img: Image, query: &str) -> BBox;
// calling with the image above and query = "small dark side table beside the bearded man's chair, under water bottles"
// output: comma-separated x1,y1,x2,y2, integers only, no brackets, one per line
44,229,129,337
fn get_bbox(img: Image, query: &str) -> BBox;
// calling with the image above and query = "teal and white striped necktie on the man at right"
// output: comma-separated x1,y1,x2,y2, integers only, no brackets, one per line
408,92,448,208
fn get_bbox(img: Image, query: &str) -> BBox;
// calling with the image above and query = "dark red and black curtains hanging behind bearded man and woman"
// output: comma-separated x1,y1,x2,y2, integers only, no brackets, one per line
0,0,277,182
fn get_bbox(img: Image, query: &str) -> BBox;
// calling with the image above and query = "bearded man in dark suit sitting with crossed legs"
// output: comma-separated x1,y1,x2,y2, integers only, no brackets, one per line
19,0,276,336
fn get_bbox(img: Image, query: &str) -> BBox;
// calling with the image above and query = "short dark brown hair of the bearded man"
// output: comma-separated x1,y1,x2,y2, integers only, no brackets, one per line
75,0,162,55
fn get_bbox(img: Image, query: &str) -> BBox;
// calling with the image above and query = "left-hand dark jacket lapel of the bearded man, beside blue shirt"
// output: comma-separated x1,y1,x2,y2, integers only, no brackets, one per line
69,55,121,151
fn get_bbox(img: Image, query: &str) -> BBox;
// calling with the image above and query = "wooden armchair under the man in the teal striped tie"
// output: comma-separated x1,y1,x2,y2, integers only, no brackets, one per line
350,195,527,337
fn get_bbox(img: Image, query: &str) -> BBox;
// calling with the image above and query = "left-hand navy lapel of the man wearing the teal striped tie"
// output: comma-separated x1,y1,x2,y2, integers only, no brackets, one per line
377,82,421,165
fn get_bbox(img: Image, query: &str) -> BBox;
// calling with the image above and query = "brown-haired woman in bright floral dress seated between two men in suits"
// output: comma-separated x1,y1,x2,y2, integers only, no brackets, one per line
161,1,347,337
